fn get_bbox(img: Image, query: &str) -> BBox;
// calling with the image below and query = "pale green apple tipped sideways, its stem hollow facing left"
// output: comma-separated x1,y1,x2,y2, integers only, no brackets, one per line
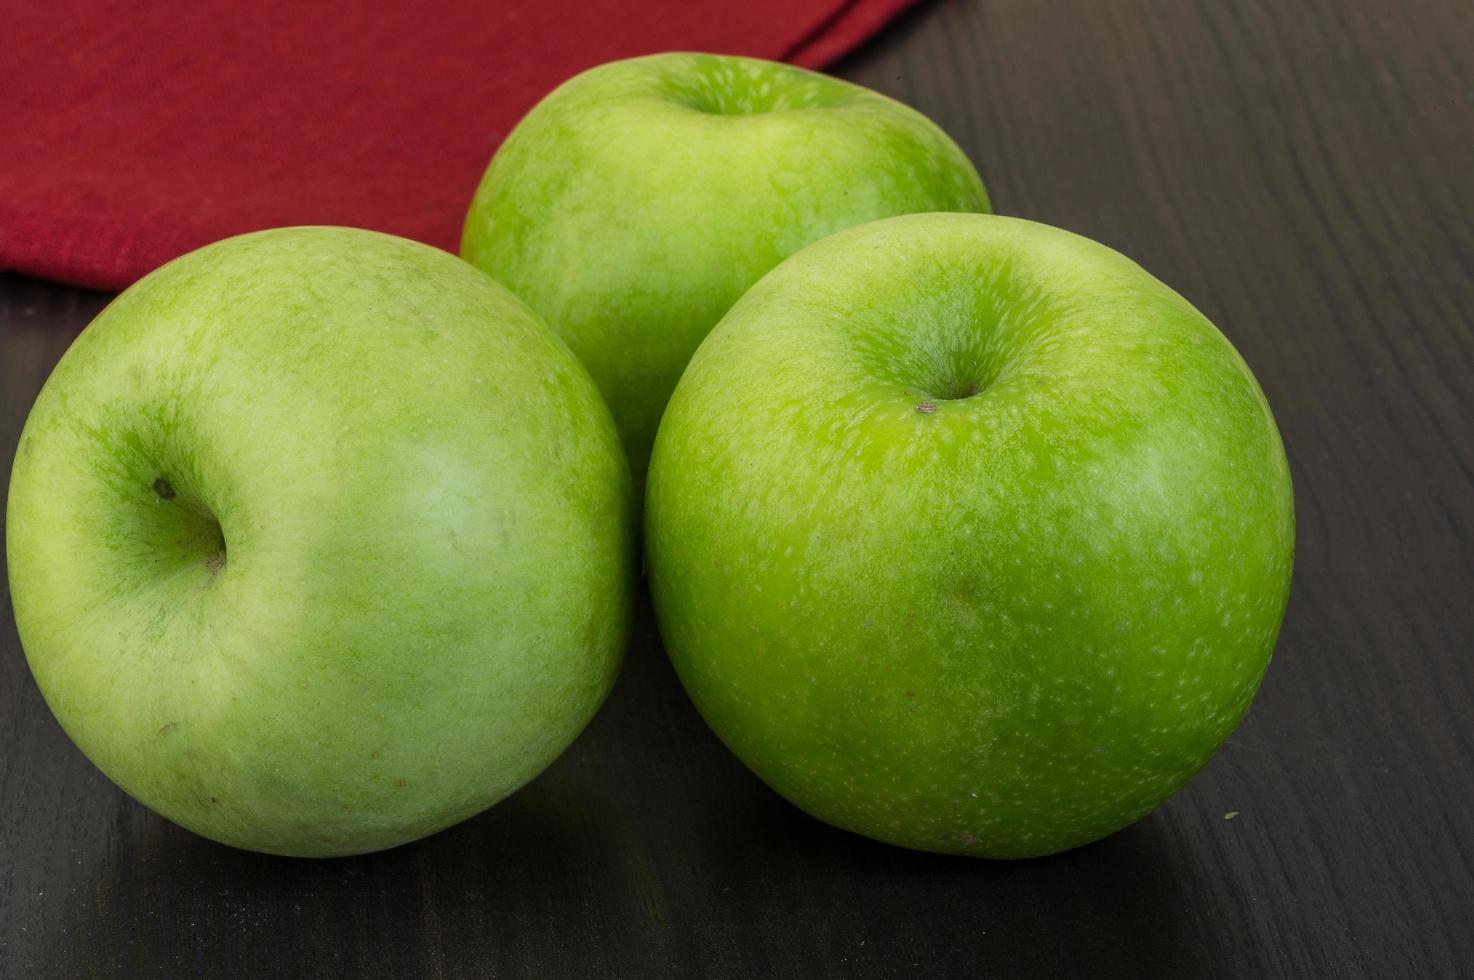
6,228,635,856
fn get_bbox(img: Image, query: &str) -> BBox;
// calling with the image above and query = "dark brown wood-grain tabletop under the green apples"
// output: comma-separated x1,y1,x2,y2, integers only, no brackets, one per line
0,0,1474,977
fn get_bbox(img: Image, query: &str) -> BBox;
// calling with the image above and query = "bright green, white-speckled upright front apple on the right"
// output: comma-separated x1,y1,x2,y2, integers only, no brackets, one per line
646,215,1294,858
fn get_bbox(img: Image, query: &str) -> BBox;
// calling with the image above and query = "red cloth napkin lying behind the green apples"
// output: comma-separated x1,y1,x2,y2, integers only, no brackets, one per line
0,0,911,289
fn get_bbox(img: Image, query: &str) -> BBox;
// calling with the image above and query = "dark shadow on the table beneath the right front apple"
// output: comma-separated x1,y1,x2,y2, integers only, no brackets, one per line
695,778,1222,977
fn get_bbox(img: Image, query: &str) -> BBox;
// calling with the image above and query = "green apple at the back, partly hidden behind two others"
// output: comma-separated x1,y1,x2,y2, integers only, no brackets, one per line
461,53,988,486
